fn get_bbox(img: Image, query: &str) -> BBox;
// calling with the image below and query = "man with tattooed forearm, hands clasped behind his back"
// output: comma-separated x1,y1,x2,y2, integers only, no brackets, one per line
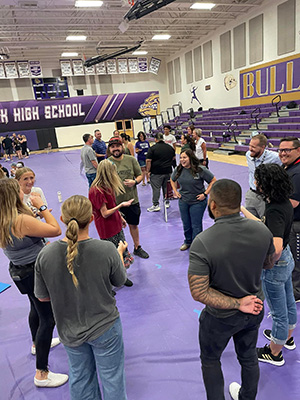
188,179,275,400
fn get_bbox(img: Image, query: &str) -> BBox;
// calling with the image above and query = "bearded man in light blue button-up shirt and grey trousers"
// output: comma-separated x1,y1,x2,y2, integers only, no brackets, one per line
245,133,282,218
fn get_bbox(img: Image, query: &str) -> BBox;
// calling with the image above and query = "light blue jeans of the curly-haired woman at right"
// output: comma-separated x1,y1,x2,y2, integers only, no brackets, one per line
262,246,297,345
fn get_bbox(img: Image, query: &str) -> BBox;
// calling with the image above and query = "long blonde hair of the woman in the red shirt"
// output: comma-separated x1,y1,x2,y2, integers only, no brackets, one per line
91,160,125,196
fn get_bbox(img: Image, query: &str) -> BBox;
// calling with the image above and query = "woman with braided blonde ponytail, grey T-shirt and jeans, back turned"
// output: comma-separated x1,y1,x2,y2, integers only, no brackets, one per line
35,195,127,400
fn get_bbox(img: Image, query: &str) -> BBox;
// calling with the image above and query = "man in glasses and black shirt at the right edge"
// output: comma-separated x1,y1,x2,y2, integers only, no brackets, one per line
278,136,300,302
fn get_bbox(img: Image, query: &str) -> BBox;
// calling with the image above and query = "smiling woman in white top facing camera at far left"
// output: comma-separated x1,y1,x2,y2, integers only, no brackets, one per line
15,167,48,216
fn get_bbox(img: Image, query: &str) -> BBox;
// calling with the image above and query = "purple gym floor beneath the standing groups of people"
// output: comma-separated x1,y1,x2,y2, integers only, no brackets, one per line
0,150,300,400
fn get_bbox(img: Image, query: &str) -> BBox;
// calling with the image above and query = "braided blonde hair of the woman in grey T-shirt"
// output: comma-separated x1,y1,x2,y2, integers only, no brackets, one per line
61,195,93,288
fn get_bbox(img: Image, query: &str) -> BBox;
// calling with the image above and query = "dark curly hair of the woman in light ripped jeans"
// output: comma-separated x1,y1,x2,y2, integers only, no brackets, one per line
254,164,294,203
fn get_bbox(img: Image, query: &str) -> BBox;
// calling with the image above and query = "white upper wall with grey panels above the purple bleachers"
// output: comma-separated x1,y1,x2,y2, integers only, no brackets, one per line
166,0,300,110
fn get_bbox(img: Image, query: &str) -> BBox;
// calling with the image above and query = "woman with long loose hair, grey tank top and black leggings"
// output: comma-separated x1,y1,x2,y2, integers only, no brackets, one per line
0,178,68,387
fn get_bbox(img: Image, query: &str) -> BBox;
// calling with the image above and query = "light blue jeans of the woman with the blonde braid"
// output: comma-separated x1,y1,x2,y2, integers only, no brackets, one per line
65,318,127,400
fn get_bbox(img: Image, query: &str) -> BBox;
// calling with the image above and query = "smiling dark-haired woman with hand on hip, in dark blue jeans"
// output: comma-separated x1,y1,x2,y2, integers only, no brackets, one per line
171,149,216,251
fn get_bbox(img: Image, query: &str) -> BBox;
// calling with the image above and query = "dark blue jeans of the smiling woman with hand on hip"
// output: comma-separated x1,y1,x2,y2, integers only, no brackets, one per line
179,199,207,244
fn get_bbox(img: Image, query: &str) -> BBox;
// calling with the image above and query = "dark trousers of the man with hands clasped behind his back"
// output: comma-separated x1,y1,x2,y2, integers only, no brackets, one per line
199,310,264,400
